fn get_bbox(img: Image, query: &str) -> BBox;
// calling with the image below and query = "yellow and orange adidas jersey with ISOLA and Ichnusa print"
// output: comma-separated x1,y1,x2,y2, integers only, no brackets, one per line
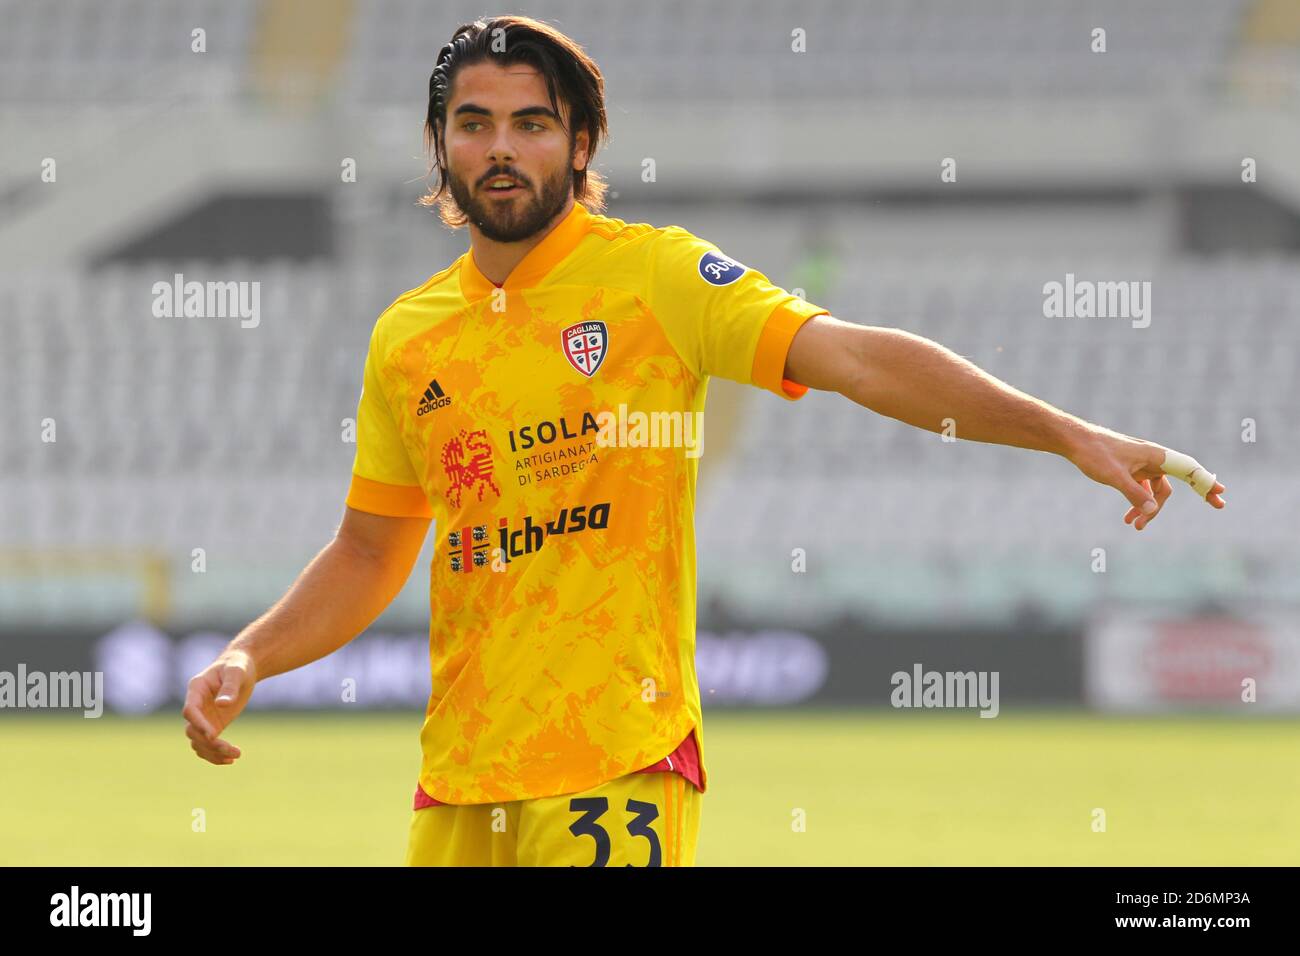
347,203,827,804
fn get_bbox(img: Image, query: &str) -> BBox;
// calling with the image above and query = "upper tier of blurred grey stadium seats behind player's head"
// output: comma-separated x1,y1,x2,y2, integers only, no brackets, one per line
346,0,1248,105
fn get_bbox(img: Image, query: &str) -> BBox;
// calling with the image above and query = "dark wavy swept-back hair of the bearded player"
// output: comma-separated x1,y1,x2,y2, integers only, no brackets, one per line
420,17,610,229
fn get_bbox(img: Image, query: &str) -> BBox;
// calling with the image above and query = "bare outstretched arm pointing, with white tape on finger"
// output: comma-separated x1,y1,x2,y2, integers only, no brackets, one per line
785,315,1225,531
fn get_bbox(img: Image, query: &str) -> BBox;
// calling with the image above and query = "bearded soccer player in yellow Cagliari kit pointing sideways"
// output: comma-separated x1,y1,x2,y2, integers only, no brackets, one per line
183,17,1223,866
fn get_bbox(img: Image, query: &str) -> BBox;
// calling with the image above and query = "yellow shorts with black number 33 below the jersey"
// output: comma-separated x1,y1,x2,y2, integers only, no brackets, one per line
406,773,701,866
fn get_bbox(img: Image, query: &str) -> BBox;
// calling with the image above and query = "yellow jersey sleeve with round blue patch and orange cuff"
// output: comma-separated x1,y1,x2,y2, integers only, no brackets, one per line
647,226,829,401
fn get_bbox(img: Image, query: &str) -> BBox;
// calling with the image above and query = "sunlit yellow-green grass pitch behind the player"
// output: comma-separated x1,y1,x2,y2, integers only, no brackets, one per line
0,710,1300,866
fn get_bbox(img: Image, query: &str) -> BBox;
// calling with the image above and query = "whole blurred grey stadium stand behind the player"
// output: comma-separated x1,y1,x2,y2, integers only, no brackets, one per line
0,0,1300,642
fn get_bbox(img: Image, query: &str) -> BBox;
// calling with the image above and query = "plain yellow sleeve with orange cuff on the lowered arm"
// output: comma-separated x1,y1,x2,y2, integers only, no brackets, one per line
347,328,433,518
